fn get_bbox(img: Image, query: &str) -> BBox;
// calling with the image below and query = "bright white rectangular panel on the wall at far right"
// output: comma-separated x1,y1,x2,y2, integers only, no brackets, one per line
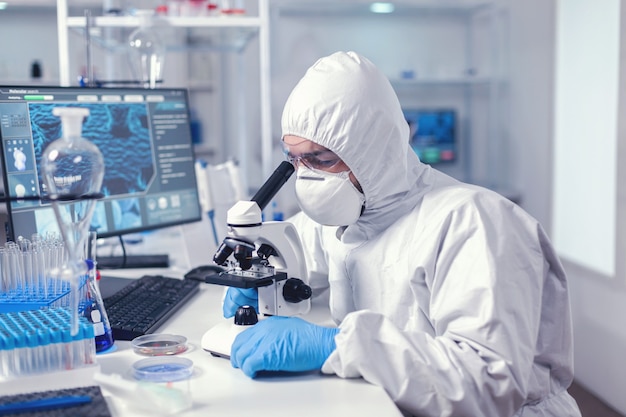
553,0,620,276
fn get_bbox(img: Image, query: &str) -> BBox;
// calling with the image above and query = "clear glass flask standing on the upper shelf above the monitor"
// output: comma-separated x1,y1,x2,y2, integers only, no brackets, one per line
128,10,165,88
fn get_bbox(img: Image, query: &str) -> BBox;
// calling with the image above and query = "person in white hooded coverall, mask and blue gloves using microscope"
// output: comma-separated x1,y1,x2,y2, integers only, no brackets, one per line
223,52,580,417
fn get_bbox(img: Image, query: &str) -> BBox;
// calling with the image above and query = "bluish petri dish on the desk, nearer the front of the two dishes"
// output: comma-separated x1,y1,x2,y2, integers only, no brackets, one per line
133,357,193,382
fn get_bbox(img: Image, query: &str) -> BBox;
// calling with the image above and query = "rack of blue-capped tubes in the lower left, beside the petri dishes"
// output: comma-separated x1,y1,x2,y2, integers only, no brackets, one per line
0,308,96,378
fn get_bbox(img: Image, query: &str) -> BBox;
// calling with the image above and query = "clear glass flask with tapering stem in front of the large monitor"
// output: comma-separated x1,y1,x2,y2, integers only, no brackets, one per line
41,107,104,335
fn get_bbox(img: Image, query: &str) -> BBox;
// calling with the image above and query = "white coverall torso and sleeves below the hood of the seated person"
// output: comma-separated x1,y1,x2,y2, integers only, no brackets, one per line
290,162,579,417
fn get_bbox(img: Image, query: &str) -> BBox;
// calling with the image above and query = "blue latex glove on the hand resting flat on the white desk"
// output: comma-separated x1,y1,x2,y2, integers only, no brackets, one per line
230,316,339,378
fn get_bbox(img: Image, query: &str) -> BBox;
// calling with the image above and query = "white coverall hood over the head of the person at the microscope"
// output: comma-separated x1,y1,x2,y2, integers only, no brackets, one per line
282,52,430,239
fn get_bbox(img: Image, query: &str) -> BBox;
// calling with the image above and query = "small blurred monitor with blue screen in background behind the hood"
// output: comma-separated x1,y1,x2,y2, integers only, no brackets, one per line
403,109,457,164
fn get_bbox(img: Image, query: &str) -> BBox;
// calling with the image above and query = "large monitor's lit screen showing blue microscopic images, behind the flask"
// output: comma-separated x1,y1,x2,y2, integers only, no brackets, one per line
0,86,201,240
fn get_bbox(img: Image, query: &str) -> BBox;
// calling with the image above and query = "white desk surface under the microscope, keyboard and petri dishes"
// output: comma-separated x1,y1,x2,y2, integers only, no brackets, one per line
0,224,402,417
